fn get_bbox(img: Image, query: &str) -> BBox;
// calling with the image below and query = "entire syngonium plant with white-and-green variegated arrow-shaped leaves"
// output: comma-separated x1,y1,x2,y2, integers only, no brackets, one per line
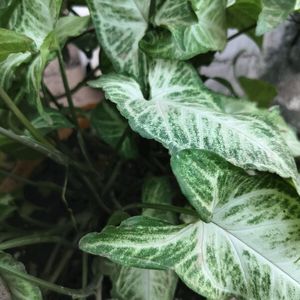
0,0,300,300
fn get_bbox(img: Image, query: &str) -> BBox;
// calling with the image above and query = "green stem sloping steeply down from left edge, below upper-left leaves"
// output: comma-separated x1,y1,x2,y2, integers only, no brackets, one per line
0,87,54,149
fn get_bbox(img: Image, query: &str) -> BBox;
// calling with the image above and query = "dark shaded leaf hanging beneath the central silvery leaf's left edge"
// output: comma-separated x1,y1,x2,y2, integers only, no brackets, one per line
91,102,137,159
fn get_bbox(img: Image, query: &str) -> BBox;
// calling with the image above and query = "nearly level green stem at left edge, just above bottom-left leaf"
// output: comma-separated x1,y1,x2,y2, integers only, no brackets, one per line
0,236,61,251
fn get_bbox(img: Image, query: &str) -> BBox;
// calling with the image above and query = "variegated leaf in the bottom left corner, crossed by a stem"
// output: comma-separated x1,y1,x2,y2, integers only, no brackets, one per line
0,252,42,300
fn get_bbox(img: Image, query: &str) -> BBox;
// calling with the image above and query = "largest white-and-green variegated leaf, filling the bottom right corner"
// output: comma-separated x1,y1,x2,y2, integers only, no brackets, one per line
80,150,300,300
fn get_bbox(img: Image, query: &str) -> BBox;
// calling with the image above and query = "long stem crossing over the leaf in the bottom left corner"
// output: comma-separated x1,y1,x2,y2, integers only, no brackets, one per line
0,265,94,298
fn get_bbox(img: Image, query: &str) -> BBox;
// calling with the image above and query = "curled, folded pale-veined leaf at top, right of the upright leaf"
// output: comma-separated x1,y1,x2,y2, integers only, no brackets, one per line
141,0,226,60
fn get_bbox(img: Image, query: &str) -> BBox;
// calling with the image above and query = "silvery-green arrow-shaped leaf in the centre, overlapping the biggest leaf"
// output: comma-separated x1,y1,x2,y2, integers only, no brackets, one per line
91,60,299,190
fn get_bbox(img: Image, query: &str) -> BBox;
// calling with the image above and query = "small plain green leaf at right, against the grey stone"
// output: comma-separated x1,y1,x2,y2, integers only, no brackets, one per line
239,77,277,107
